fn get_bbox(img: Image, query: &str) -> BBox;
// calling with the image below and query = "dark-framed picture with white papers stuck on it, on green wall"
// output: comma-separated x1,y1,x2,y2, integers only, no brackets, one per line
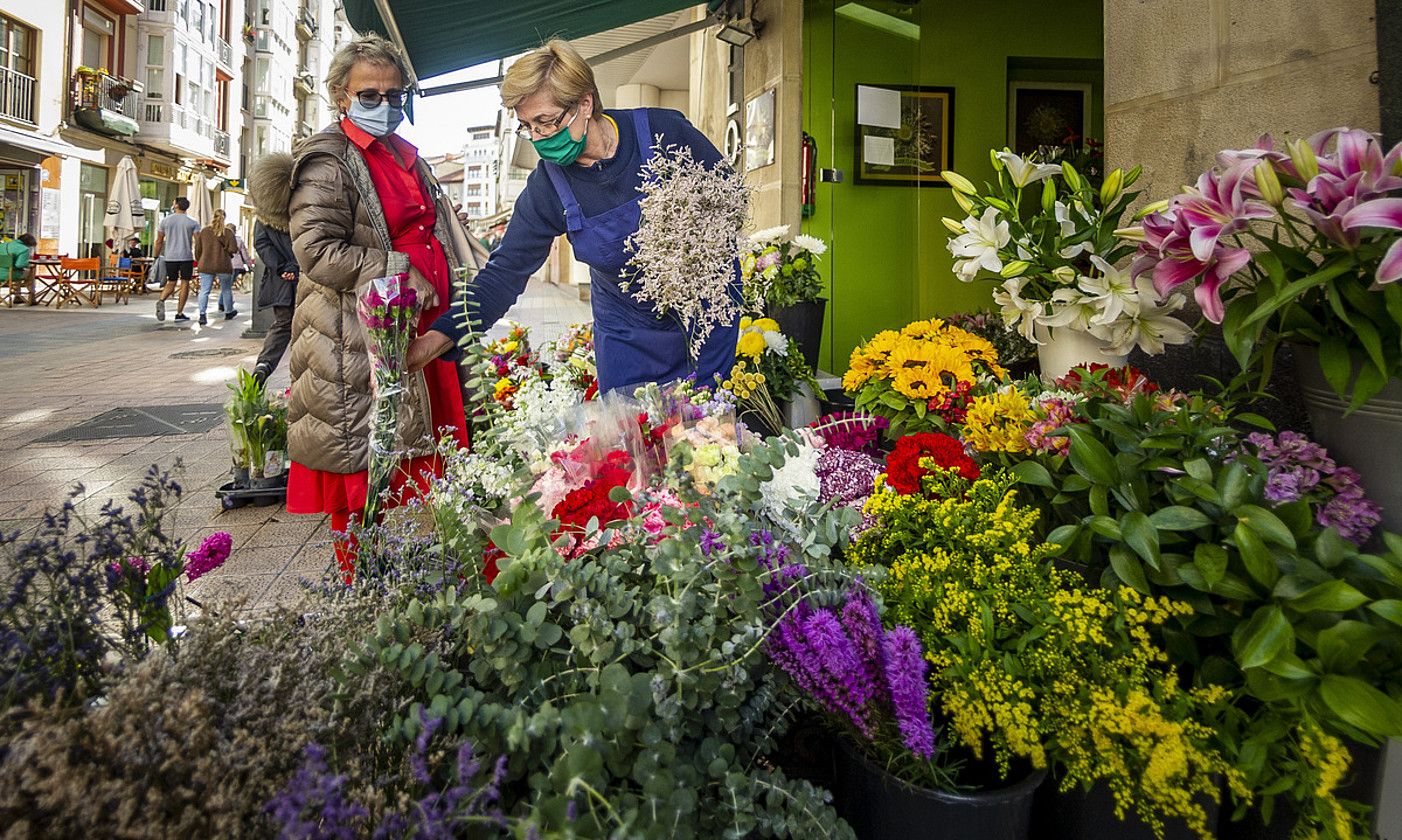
852,84,955,187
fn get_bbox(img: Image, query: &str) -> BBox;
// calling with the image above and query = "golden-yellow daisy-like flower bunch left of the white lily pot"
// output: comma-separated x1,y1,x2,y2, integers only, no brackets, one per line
843,318,1004,401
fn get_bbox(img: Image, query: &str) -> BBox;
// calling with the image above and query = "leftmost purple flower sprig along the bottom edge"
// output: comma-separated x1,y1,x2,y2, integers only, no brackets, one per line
264,743,370,840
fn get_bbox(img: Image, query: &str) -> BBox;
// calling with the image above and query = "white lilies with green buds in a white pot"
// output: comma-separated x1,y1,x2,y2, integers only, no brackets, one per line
942,150,1192,376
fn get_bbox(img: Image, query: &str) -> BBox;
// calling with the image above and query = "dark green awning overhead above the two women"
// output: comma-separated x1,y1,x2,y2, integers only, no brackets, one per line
345,0,712,79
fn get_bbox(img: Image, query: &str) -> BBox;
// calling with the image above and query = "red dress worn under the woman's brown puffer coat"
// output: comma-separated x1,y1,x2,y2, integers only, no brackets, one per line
287,119,467,535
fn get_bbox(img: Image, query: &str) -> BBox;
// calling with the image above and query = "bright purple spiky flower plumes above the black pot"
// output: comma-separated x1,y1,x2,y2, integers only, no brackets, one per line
768,582,935,760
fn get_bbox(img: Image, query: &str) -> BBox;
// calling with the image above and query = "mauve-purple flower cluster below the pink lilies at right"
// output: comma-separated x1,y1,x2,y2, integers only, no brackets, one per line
1246,432,1382,546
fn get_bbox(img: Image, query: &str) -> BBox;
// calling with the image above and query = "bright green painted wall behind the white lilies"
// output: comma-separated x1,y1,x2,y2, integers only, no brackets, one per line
803,0,1103,373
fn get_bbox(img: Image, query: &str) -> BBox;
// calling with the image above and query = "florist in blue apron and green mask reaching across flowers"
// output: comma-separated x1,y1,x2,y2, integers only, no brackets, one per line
409,41,740,393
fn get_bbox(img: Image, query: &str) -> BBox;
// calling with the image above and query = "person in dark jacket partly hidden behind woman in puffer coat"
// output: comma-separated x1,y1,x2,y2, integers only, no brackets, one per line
250,154,301,381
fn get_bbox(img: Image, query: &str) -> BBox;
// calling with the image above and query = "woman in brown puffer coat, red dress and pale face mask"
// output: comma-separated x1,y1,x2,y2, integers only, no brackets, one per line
287,35,475,578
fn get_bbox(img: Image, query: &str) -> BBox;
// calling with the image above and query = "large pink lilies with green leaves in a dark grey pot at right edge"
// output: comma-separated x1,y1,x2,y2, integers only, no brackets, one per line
1133,128,1402,530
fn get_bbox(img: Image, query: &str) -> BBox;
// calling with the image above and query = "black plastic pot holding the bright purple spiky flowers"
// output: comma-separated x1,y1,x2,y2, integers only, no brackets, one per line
834,740,1046,840
